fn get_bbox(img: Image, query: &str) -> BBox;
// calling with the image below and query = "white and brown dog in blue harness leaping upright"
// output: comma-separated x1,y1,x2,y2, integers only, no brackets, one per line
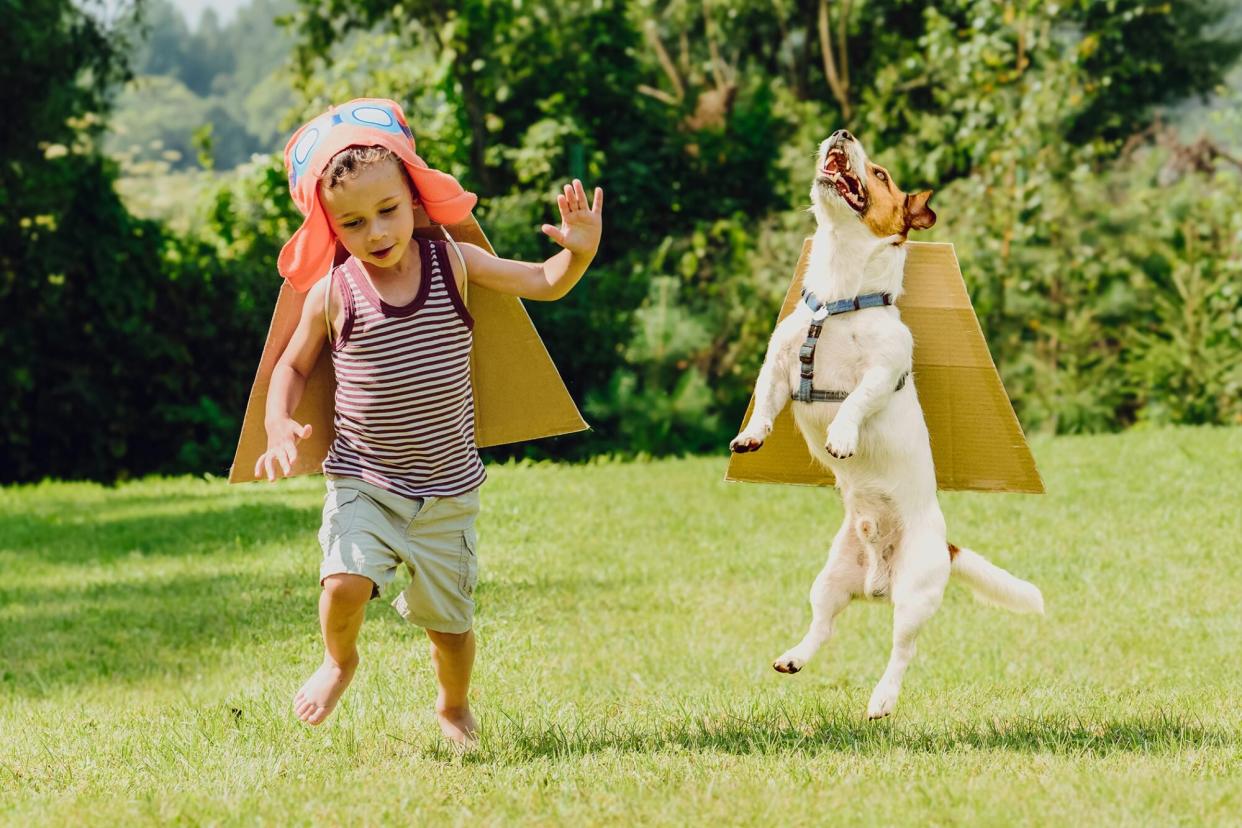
729,130,1043,719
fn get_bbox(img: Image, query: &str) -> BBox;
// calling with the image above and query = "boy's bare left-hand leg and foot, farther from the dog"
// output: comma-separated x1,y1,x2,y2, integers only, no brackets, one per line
293,574,375,725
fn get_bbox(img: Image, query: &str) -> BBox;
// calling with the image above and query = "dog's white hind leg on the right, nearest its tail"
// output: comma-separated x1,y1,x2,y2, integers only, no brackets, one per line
867,529,949,719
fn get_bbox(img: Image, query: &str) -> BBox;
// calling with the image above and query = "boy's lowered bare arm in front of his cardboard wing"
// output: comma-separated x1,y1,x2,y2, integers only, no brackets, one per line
255,277,329,480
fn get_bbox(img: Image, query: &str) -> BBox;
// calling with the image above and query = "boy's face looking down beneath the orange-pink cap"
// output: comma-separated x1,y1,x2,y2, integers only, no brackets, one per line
319,158,414,267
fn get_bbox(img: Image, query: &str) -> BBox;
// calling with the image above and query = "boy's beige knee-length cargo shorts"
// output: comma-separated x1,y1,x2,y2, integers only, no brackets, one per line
319,477,478,633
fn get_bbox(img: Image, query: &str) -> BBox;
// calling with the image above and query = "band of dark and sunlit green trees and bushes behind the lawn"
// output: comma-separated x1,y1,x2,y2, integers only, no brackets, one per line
0,0,1242,480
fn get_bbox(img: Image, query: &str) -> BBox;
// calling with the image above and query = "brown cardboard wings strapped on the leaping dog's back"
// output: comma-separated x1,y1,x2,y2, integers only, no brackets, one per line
725,238,1043,494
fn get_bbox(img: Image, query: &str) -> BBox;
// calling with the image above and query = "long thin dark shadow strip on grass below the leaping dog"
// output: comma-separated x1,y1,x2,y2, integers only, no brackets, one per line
452,710,1238,765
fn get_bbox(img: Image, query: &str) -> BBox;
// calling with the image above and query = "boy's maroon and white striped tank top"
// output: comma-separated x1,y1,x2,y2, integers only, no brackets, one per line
323,238,486,498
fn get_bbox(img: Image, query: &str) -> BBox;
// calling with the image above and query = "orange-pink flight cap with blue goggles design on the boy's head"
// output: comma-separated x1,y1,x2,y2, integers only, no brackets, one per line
277,98,478,292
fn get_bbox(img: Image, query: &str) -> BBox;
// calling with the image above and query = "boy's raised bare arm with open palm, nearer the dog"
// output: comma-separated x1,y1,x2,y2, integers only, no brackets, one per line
461,179,604,299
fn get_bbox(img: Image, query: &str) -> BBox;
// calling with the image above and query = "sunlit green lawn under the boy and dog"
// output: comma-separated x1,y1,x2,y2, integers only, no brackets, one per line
0,428,1242,826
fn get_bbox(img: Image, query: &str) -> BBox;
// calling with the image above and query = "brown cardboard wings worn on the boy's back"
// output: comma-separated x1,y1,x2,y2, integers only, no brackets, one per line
229,210,587,483
